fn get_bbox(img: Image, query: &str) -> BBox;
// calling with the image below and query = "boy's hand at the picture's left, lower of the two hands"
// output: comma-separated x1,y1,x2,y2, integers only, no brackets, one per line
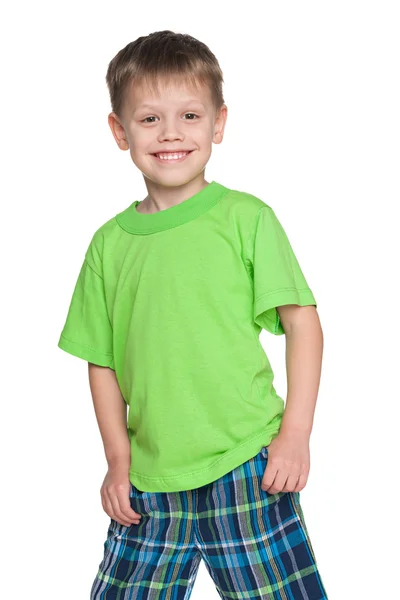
100,469,142,527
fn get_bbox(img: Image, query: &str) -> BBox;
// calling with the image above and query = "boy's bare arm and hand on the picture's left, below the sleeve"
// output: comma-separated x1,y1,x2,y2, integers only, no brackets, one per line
88,363,141,527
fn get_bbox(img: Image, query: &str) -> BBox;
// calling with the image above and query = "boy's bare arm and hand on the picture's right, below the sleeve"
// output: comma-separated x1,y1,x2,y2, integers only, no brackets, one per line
261,304,323,494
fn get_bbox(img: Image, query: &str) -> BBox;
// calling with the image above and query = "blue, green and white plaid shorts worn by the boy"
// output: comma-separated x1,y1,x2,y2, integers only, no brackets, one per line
90,446,327,600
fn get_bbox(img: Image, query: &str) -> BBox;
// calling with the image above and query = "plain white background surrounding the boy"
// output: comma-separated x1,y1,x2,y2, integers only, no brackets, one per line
1,0,400,600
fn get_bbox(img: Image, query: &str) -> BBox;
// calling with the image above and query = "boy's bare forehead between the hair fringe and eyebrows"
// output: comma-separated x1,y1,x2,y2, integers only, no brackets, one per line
126,79,212,112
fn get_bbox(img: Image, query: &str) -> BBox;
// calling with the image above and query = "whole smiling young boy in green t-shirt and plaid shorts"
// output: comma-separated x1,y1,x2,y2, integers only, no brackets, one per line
59,31,327,600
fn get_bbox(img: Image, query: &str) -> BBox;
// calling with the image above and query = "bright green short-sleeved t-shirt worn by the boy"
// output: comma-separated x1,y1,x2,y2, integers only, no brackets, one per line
58,181,317,492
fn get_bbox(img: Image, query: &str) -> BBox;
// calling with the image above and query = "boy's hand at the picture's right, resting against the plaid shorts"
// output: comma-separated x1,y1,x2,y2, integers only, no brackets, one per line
261,432,310,494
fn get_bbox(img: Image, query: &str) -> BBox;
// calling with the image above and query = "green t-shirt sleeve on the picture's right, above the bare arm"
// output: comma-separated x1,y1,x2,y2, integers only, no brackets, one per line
247,204,317,335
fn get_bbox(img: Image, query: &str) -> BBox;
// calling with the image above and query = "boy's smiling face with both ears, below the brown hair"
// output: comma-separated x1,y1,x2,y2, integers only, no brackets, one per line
108,77,227,187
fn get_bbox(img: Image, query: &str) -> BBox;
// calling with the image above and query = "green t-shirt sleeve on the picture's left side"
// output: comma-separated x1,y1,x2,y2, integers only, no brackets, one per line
58,236,114,369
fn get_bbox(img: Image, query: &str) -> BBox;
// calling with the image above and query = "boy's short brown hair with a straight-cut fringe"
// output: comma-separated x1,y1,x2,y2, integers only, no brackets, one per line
106,29,224,116
